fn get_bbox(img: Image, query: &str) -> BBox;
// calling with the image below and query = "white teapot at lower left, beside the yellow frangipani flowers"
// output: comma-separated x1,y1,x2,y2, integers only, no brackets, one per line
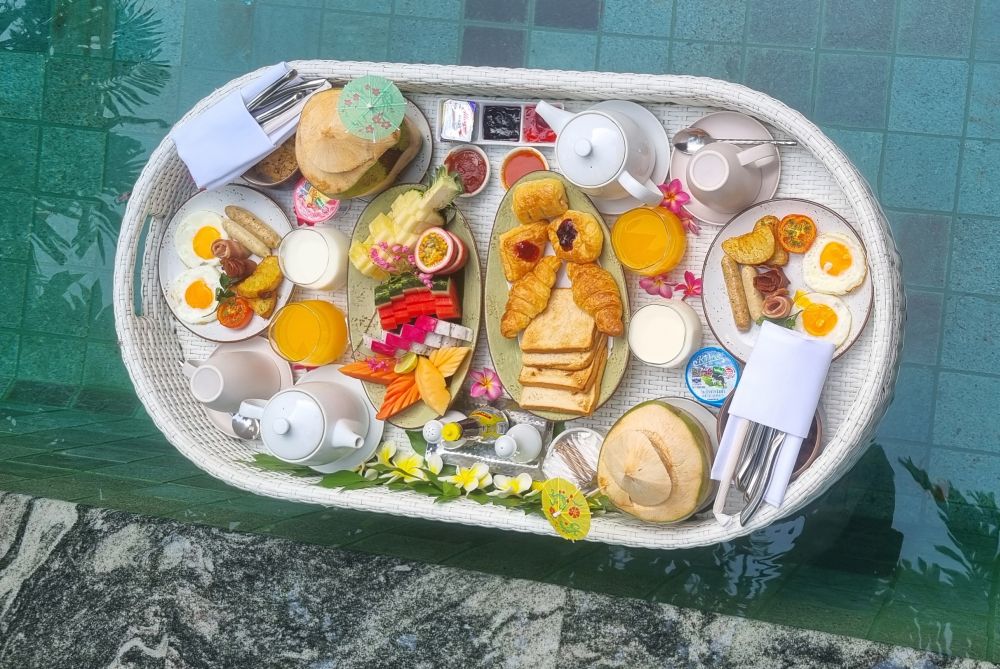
240,381,369,472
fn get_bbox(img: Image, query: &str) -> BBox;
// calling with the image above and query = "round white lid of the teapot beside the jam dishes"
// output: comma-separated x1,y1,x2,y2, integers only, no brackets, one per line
556,111,625,187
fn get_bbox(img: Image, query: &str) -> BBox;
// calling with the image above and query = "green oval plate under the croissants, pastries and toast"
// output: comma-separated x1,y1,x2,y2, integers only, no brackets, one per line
485,172,630,421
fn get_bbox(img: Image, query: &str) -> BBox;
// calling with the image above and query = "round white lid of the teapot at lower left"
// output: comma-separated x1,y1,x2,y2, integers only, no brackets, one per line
260,388,326,461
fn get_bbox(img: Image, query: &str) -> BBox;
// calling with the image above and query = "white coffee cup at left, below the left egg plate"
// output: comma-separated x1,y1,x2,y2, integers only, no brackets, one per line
183,351,281,412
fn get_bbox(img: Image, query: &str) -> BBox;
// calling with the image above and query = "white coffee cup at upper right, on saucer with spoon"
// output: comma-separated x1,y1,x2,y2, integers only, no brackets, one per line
686,142,778,214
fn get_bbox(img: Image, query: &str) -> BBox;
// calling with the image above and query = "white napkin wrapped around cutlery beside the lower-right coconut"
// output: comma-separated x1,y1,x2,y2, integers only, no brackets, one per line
712,322,835,525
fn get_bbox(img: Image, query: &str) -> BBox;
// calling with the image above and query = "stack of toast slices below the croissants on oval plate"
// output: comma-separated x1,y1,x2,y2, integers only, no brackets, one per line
519,288,608,416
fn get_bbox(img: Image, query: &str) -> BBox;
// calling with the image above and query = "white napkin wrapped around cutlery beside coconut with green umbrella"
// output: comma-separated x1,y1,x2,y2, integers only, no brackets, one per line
170,63,330,190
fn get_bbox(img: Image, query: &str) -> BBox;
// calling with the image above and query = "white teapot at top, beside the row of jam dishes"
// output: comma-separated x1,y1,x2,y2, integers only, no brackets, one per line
535,101,663,206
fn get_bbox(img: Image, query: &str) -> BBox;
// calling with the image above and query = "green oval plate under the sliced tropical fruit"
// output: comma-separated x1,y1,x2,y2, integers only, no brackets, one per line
347,184,483,430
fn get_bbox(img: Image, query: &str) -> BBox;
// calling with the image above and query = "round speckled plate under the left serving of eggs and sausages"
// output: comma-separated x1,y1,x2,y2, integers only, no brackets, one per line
157,184,292,343
